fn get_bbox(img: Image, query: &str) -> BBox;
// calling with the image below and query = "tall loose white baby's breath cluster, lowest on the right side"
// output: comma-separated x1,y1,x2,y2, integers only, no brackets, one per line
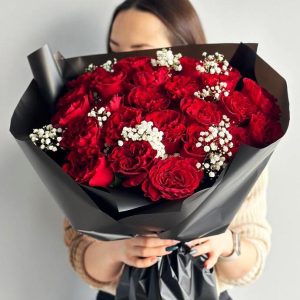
196,115,234,178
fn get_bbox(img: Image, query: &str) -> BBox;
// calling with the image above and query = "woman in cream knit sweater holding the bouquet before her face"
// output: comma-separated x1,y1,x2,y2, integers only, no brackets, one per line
64,0,271,300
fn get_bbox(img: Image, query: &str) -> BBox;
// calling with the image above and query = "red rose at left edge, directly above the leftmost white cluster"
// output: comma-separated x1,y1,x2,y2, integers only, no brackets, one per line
51,86,91,127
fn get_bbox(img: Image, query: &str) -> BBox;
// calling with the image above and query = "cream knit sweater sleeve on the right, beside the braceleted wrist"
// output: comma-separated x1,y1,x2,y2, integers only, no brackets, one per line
217,169,271,291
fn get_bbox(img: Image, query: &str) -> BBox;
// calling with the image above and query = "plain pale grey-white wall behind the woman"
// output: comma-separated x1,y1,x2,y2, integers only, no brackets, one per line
0,0,300,300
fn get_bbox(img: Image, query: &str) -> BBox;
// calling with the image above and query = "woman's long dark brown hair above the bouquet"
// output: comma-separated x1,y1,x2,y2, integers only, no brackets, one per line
107,0,206,52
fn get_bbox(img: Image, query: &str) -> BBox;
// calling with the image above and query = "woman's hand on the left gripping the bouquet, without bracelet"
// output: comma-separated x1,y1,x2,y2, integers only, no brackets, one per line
116,235,180,268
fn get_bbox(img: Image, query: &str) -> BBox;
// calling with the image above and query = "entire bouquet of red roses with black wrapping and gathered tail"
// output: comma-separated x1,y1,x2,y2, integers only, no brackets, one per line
11,44,289,299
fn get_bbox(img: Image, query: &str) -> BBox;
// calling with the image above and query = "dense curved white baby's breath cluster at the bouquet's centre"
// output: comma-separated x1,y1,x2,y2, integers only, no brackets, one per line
118,121,167,159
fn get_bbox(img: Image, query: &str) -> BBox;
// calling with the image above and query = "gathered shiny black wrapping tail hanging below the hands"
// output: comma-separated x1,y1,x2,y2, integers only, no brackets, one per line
116,242,218,300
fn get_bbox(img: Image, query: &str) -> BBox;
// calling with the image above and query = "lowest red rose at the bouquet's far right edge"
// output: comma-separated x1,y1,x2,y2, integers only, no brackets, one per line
248,113,283,147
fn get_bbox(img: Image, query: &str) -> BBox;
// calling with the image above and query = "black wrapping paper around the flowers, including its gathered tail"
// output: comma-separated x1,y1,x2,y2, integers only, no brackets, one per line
10,44,289,300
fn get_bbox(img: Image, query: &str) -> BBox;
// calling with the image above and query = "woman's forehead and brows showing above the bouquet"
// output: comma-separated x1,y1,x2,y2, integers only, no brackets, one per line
110,9,171,52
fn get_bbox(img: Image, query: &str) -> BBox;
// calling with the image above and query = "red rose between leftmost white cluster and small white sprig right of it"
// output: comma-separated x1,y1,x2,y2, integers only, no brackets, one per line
60,117,101,151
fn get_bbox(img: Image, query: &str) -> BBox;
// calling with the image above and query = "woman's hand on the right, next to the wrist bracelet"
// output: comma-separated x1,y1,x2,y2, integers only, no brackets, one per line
186,229,233,269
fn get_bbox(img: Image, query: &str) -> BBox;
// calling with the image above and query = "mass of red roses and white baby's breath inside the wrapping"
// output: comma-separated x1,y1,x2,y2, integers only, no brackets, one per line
30,49,283,201
